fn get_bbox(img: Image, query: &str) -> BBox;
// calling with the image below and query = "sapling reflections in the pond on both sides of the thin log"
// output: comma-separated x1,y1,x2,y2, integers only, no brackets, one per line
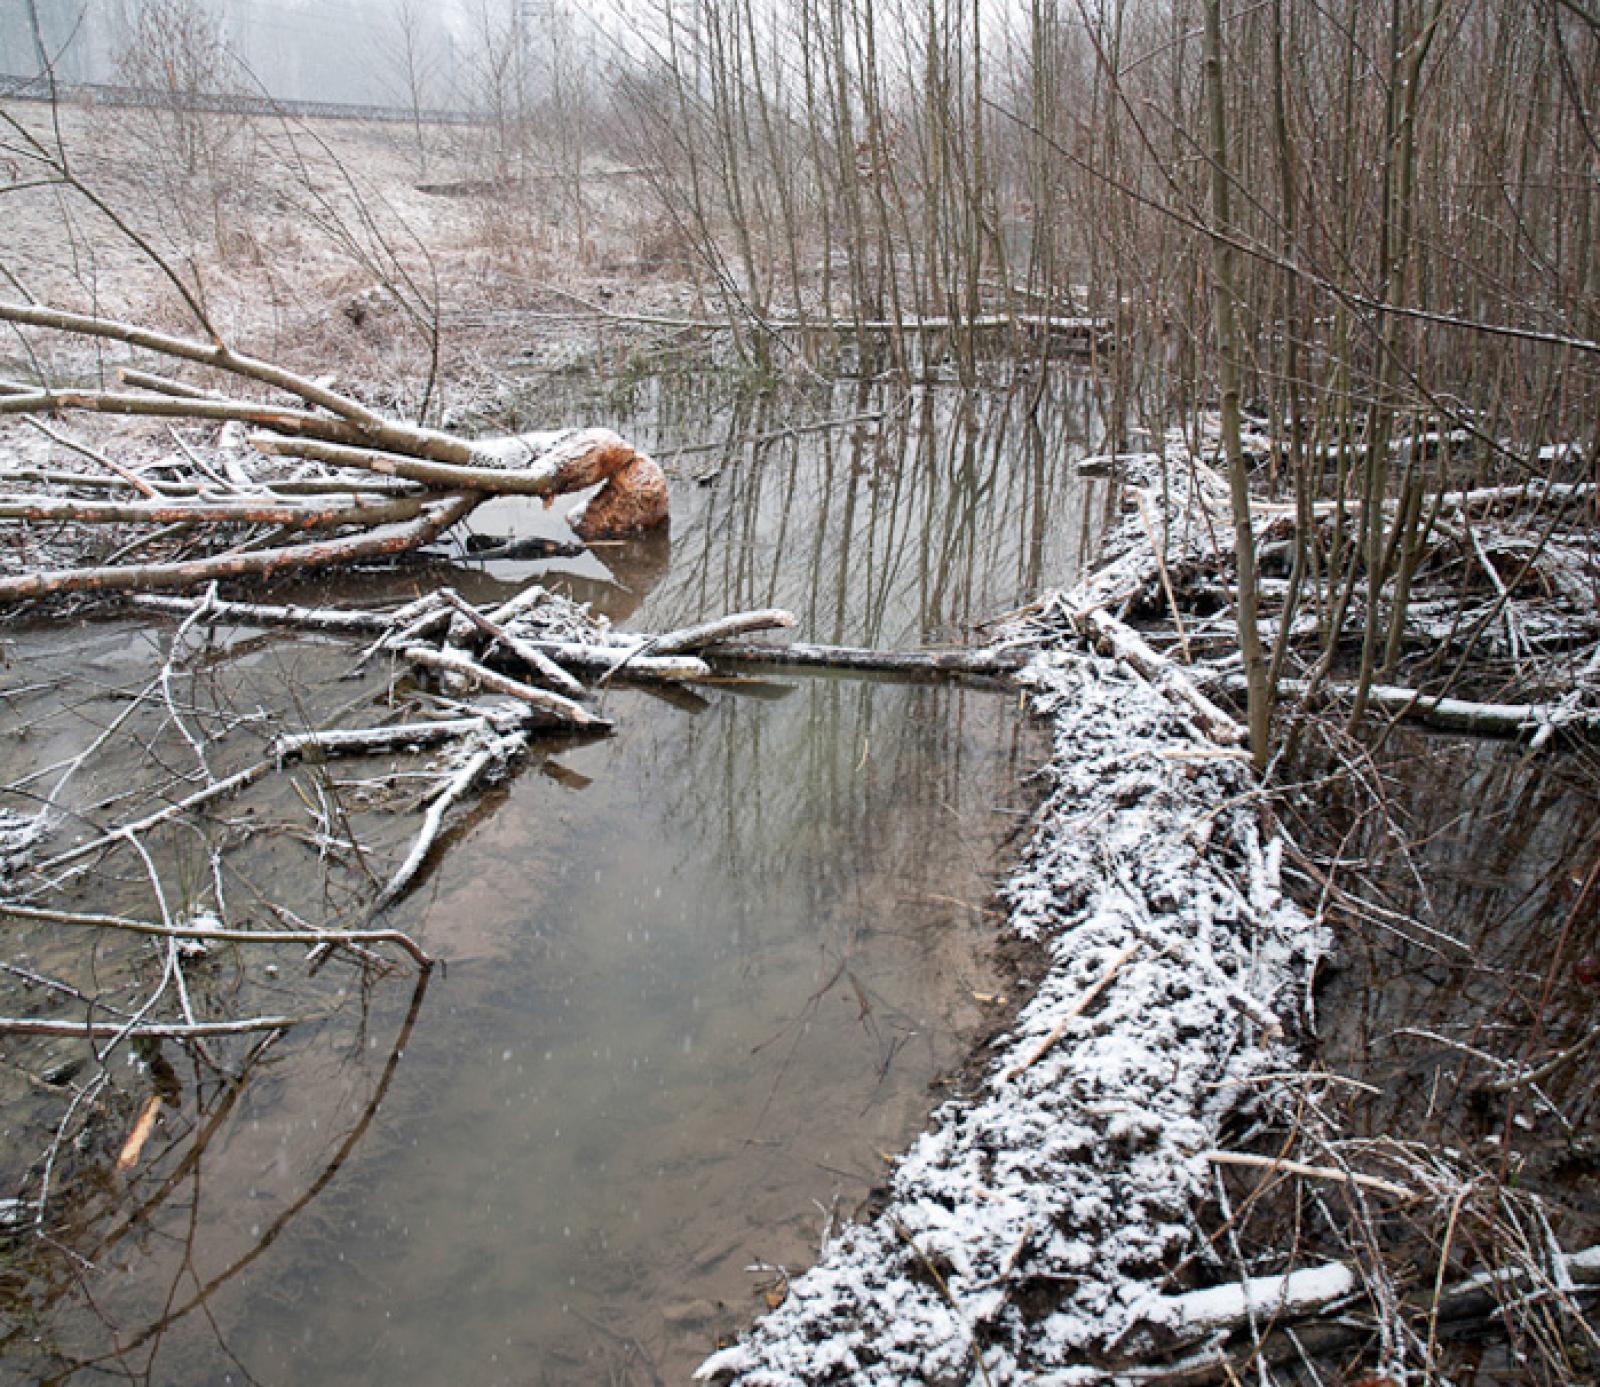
444,373,1098,966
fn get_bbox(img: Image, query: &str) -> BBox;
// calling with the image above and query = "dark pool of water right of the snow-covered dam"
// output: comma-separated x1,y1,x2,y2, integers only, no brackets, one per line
1310,729,1600,1203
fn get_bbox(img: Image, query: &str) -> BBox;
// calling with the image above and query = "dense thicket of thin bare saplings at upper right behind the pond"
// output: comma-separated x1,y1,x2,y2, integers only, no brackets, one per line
43,0,1600,763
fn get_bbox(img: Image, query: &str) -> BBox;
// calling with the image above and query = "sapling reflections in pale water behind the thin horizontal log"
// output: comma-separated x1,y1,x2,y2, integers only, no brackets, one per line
442,371,1101,646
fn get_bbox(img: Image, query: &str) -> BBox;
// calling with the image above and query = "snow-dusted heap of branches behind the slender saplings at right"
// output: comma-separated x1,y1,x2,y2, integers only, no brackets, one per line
1075,430,1600,747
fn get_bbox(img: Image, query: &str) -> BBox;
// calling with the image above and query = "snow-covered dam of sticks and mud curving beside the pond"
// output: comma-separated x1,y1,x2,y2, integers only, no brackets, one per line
699,440,1600,1387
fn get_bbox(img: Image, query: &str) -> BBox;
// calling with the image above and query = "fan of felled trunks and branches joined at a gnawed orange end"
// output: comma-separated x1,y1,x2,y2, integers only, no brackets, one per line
0,302,667,606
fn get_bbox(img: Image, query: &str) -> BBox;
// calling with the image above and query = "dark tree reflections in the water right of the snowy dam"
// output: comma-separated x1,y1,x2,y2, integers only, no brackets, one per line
1328,733,1600,1134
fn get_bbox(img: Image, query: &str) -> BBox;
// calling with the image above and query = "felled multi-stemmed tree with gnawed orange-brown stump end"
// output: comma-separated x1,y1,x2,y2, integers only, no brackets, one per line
0,301,667,603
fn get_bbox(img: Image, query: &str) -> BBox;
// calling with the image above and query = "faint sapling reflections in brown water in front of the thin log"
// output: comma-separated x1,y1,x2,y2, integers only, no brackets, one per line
611,677,1029,972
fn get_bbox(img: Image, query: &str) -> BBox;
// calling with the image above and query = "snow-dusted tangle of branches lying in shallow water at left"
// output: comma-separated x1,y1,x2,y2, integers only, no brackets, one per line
0,587,794,1254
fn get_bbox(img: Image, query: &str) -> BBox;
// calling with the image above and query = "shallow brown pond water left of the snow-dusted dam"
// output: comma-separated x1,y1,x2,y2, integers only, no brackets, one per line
0,374,1104,1384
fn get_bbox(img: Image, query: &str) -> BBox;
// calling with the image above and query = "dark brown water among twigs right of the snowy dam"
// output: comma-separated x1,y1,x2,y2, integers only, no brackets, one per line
1280,728,1600,1387
